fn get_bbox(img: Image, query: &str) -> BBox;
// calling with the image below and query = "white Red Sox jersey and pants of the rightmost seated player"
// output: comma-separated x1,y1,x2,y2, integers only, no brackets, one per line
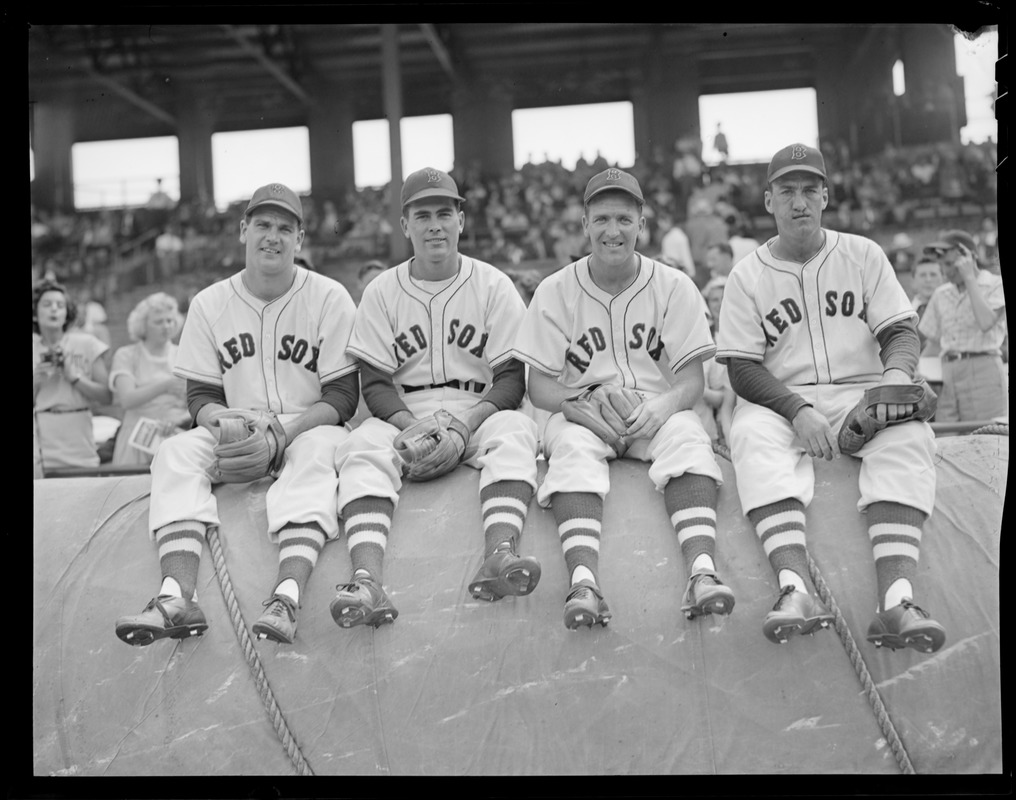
716,229,935,513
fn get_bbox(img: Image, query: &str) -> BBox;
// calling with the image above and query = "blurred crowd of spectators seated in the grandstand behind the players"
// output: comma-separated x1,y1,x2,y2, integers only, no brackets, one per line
31,139,998,300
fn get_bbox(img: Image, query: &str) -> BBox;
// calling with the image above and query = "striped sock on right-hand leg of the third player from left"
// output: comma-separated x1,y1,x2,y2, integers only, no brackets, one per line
663,473,716,575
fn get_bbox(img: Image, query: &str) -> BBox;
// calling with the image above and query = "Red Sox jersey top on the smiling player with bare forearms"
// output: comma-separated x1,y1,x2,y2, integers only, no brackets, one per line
514,253,715,394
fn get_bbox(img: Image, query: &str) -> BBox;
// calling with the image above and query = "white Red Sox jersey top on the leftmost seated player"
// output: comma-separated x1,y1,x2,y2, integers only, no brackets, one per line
174,266,358,415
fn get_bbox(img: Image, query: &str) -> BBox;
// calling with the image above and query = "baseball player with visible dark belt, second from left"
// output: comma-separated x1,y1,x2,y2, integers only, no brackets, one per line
331,169,541,628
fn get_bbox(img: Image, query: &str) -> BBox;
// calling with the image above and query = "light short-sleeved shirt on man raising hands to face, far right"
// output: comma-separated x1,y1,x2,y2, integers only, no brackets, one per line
917,269,1006,353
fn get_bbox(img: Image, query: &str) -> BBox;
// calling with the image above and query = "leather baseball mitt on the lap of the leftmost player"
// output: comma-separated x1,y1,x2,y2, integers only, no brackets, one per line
210,409,287,483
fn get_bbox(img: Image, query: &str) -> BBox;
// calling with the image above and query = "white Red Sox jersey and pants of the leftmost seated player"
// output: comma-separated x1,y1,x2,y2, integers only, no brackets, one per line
149,266,359,537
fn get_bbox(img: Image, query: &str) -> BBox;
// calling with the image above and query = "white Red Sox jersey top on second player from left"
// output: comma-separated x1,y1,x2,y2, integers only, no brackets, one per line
348,255,525,386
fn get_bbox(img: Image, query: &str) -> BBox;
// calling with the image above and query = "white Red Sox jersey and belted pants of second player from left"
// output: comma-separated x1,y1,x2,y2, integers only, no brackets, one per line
336,255,536,509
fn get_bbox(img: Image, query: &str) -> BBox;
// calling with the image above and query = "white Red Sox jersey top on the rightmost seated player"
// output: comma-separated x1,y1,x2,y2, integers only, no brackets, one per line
716,230,916,385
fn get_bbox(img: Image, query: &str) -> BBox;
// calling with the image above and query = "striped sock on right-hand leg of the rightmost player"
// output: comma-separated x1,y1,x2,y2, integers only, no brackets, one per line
868,501,928,611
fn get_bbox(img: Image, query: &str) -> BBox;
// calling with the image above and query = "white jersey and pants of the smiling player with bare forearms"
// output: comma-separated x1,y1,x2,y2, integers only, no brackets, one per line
515,254,722,507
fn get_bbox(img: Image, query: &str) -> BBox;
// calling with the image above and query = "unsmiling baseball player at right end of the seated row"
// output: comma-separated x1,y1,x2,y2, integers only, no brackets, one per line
716,144,945,653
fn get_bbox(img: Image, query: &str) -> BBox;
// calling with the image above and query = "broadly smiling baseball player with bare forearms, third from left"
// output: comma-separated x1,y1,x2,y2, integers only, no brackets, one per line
514,169,734,630
